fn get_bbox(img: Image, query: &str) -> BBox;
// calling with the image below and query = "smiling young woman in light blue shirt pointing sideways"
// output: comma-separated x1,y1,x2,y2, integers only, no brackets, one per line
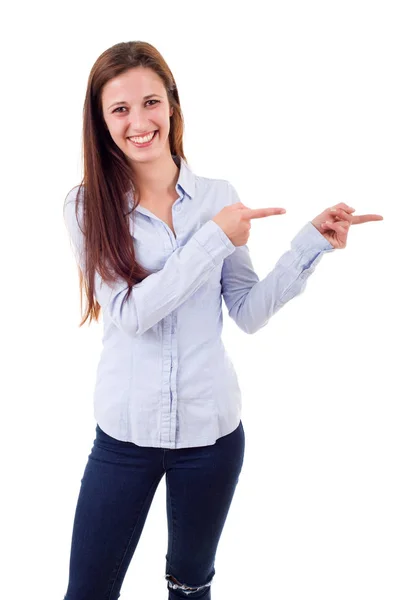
64,42,382,600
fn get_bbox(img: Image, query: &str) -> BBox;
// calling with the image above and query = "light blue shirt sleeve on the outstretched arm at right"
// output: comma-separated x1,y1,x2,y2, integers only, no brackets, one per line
221,183,334,333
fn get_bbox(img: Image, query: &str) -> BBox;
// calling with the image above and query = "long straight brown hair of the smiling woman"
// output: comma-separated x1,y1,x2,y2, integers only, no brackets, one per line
69,41,186,327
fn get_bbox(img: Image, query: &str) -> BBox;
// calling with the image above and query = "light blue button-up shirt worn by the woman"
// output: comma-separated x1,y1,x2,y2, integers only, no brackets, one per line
64,156,334,448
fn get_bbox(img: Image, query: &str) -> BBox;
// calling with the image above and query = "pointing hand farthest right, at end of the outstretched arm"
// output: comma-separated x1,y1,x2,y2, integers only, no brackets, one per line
311,202,383,248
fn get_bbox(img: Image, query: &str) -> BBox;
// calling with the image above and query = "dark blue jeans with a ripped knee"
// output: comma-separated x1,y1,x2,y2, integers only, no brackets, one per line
64,422,245,600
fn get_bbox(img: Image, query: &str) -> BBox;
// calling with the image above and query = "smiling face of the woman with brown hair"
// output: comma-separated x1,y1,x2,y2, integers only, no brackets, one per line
101,67,173,163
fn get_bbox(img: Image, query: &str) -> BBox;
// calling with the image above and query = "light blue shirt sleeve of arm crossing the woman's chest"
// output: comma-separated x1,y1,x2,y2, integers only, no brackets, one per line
63,188,235,337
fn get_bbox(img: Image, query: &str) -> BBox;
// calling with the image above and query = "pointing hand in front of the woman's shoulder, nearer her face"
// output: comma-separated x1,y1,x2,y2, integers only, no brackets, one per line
212,202,286,246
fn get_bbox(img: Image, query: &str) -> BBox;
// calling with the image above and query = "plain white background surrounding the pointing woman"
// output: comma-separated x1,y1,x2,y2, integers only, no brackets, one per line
0,0,400,600
